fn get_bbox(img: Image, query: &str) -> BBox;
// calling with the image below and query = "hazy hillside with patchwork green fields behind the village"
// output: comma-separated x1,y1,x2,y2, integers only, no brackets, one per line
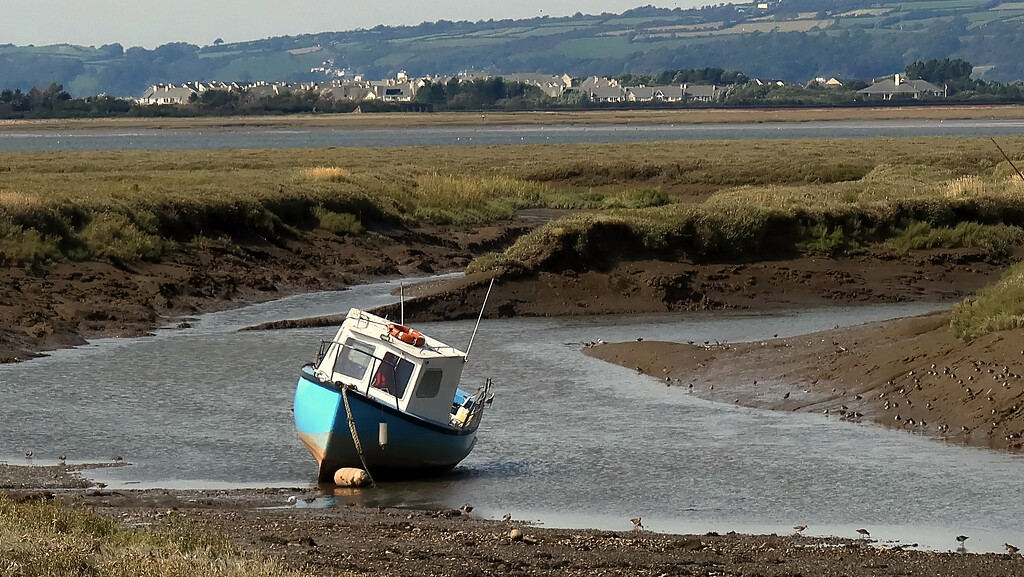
6,0,1024,96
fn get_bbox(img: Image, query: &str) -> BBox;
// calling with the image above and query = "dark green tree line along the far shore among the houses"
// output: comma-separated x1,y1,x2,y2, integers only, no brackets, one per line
6,58,1024,119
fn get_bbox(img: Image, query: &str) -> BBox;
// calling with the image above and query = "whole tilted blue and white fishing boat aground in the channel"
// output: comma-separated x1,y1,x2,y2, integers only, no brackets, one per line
294,308,494,483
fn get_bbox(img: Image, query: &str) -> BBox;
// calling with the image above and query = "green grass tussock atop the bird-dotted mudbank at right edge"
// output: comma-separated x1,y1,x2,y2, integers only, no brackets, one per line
949,262,1024,342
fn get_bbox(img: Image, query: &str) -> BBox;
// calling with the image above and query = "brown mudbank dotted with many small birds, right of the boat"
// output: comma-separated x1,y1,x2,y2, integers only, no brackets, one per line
587,313,1024,451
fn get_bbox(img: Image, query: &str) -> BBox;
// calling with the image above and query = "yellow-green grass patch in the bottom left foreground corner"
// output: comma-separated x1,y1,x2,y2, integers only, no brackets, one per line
0,494,298,577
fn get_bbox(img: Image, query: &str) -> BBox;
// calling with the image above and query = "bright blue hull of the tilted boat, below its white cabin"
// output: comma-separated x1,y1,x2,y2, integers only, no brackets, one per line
294,367,476,483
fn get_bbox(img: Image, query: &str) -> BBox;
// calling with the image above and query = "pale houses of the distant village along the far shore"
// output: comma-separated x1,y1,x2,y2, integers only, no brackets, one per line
136,69,946,105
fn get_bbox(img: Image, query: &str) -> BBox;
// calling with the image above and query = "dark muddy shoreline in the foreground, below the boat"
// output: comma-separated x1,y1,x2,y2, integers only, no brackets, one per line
0,465,1024,577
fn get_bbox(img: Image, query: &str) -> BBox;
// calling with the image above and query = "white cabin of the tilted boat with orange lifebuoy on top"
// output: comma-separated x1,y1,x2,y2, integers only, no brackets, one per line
314,308,466,425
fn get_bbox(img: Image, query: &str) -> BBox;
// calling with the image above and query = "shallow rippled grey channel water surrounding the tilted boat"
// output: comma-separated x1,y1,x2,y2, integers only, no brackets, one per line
0,284,1024,551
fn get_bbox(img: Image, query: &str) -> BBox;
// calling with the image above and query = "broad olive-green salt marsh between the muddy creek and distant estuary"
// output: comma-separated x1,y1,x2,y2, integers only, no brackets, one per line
0,137,1024,340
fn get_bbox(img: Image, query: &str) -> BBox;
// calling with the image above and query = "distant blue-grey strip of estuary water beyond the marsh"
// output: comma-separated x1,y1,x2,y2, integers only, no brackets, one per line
6,120,1024,152
